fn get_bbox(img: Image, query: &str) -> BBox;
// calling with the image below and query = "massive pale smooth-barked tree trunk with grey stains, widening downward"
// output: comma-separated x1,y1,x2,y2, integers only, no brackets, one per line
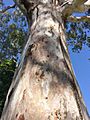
1,0,89,120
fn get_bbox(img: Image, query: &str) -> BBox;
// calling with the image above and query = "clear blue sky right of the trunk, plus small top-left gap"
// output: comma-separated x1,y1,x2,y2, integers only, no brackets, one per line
4,0,90,114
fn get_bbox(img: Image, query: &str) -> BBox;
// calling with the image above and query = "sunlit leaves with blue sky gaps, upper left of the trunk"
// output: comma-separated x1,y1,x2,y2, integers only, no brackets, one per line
0,5,27,59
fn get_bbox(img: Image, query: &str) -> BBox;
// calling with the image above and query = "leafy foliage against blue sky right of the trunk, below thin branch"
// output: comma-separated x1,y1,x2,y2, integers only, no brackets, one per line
66,22,90,52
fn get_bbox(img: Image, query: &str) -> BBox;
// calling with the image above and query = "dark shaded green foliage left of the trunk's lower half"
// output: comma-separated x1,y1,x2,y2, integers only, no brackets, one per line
0,59,16,115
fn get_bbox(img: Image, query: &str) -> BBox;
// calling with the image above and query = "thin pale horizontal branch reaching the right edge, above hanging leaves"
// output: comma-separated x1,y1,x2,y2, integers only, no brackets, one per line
67,16,90,23
